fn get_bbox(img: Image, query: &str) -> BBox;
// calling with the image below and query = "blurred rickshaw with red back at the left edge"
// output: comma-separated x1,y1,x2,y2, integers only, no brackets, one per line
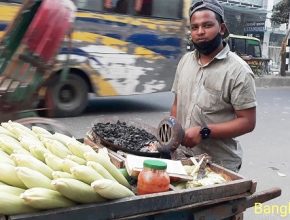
0,0,76,134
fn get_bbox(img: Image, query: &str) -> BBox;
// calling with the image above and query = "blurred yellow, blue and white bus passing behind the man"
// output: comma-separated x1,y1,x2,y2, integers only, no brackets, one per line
0,0,191,117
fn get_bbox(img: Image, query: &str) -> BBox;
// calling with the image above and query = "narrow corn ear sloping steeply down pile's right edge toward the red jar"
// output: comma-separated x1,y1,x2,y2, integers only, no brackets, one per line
84,152,130,188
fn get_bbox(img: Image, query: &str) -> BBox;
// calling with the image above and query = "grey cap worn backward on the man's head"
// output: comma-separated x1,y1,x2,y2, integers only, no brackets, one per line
189,0,230,38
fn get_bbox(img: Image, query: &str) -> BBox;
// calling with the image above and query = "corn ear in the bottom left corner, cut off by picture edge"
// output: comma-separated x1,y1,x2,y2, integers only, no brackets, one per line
0,192,36,215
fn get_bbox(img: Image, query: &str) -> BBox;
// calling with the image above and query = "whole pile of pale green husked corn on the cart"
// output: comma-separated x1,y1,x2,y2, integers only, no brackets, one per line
0,121,134,215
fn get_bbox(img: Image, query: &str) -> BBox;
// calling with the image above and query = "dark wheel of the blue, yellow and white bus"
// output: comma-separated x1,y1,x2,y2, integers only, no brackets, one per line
45,73,88,117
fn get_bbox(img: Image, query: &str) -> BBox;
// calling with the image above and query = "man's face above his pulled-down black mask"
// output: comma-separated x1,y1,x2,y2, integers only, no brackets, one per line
190,10,225,43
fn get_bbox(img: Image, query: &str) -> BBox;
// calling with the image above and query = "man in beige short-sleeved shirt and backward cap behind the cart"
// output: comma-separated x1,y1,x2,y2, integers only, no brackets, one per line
171,0,256,172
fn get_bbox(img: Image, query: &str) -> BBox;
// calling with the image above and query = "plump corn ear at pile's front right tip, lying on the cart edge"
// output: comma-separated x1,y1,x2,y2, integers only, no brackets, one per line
91,179,135,199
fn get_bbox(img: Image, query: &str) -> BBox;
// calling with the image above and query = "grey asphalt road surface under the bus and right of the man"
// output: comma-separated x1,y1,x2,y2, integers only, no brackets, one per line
59,87,290,220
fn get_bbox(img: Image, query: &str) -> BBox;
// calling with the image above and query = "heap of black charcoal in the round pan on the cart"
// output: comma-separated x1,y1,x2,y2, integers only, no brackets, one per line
93,121,157,151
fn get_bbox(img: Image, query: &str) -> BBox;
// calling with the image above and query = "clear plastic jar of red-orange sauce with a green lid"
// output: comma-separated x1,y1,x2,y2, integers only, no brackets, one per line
137,160,170,195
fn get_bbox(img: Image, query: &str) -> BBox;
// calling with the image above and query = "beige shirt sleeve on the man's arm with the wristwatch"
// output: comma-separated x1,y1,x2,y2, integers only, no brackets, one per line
231,71,257,110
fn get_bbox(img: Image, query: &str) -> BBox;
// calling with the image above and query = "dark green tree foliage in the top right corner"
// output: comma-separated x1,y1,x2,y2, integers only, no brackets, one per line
271,0,290,24
